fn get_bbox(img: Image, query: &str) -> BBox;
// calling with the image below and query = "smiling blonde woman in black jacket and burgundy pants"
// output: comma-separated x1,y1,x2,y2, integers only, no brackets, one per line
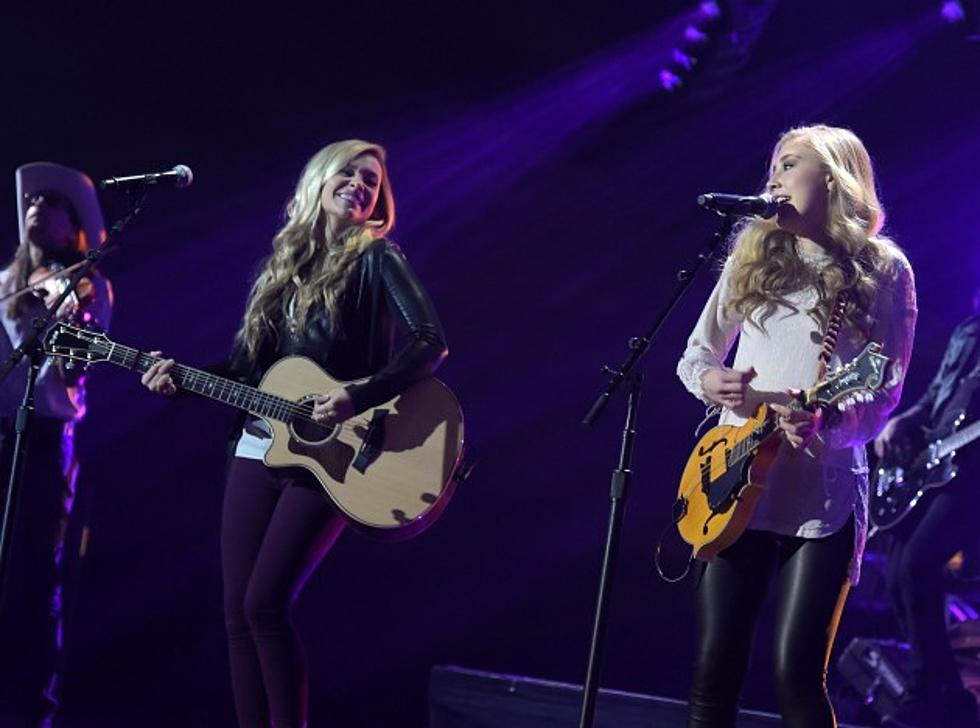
143,140,446,728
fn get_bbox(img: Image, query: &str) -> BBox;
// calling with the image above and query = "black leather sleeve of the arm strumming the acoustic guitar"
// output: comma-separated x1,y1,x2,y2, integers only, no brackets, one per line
346,245,447,413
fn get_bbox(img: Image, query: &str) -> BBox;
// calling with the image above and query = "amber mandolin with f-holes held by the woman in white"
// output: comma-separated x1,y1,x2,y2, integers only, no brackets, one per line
673,342,888,561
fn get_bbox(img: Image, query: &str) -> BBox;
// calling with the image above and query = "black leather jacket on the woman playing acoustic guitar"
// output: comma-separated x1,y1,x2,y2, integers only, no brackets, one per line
229,239,447,413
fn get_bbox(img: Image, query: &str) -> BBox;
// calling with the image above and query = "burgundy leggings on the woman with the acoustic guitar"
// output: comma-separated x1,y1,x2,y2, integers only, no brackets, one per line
221,458,344,728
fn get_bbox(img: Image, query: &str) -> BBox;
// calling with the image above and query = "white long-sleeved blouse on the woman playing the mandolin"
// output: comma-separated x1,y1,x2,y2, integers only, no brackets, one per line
677,249,917,584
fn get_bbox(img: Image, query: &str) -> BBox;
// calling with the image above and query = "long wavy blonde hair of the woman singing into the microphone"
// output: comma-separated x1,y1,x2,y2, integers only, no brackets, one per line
728,124,900,336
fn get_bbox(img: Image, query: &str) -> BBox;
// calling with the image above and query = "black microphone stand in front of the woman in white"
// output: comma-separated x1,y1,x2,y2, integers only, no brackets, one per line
579,215,736,728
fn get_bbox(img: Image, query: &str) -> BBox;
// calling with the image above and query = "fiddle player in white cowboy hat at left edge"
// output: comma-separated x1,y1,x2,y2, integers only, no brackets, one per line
0,162,112,726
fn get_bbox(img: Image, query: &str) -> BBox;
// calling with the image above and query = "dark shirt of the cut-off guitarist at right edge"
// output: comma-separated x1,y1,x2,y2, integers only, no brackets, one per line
904,315,980,431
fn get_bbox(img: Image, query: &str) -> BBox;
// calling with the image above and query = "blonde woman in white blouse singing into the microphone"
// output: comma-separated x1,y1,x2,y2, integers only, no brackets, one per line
677,126,916,728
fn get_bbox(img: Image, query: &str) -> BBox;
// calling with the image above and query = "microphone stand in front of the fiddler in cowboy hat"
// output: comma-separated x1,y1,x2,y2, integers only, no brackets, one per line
0,187,147,613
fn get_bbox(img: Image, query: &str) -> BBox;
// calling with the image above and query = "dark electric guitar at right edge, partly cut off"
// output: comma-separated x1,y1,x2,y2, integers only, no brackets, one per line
868,414,980,536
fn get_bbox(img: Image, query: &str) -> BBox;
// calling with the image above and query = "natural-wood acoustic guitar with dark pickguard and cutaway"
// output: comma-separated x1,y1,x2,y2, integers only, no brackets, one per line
45,324,463,539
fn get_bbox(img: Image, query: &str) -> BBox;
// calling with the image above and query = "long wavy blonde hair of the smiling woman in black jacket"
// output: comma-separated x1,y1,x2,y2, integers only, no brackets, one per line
235,139,395,357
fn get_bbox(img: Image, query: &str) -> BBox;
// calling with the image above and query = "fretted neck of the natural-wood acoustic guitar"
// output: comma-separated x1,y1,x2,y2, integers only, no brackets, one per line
105,342,297,422
